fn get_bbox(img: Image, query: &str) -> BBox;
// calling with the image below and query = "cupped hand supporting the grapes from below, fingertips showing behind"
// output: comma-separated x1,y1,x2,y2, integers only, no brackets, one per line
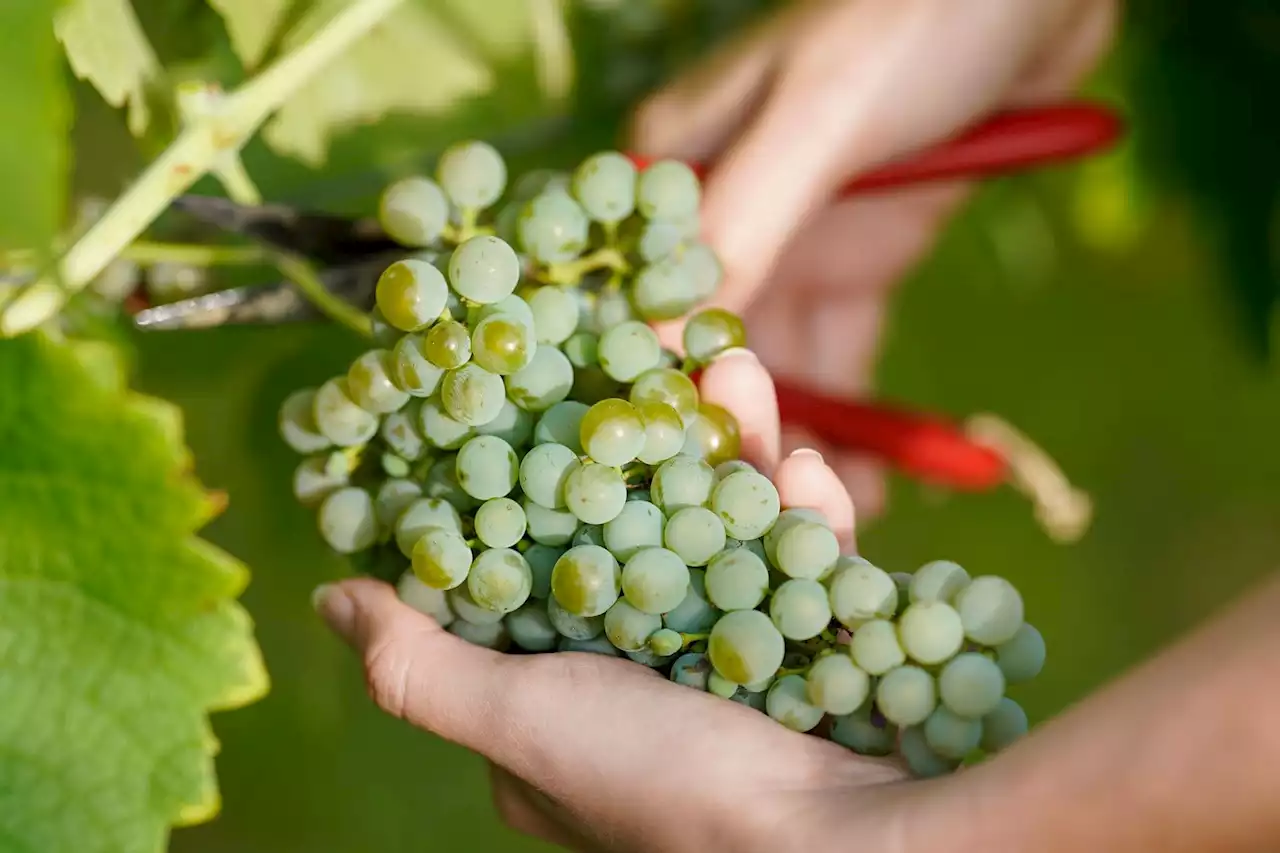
309,350,916,853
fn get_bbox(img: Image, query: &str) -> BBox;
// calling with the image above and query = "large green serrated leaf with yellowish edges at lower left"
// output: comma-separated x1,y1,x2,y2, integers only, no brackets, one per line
0,334,268,853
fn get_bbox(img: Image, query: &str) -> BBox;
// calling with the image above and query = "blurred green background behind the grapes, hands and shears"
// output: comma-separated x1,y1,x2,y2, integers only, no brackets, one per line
52,0,1280,853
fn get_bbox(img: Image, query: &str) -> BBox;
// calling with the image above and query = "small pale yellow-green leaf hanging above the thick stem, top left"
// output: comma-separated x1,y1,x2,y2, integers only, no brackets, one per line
56,0,160,136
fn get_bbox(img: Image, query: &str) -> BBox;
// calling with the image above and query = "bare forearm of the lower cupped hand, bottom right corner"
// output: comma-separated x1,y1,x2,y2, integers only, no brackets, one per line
913,568,1280,853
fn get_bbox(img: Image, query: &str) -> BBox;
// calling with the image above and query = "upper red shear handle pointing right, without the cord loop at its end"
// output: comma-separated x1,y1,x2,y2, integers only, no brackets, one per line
631,101,1123,196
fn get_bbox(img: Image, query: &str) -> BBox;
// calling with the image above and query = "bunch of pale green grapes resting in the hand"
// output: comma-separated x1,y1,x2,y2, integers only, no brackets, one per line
280,142,1044,776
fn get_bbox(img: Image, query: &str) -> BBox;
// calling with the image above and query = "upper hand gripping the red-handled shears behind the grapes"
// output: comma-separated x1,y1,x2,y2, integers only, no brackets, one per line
630,0,1116,517
